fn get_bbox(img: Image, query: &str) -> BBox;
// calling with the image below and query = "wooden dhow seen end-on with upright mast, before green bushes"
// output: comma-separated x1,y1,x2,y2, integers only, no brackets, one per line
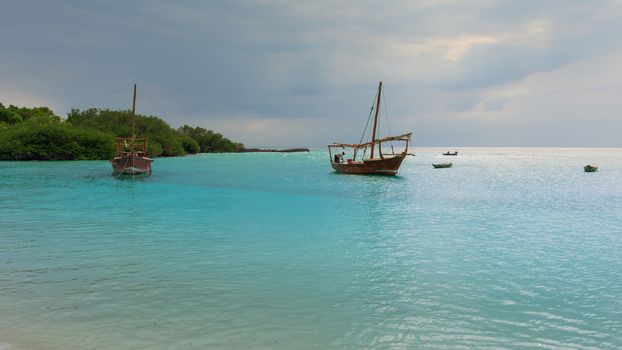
110,84,153,175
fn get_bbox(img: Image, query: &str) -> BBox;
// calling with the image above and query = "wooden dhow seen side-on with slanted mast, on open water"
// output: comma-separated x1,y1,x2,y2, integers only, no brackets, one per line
328,82,414,175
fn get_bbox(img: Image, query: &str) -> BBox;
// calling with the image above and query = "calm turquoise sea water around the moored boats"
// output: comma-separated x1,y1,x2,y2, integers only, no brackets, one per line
0,148,622,350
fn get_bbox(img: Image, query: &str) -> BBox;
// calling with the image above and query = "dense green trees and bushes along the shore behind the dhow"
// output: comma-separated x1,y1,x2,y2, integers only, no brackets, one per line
0,103,244,160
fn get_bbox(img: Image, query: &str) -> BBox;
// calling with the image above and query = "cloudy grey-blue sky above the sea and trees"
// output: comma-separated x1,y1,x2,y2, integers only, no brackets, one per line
0,0,622,147
